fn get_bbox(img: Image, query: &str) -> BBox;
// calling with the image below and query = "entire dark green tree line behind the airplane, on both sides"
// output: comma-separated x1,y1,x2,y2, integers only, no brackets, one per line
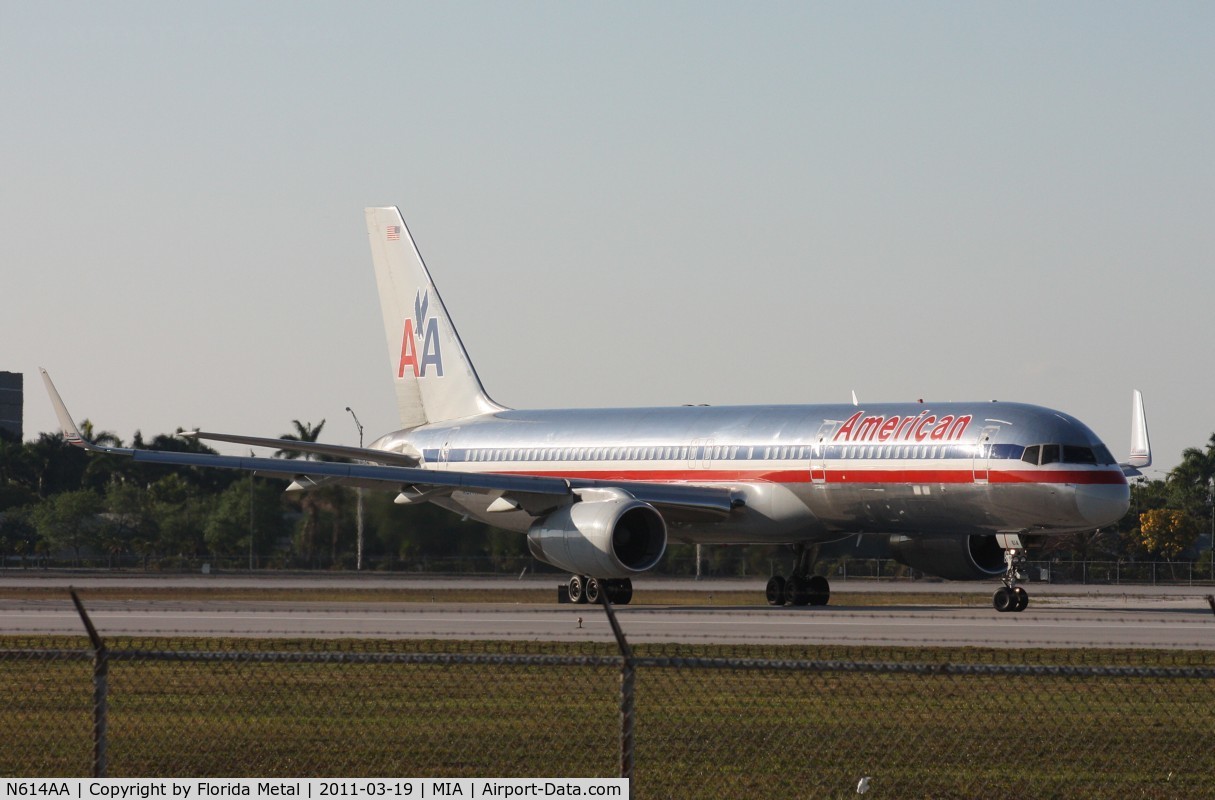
0,419,1215,575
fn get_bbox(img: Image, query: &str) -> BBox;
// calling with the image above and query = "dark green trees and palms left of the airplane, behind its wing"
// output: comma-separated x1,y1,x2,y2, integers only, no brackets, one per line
0,419,529,569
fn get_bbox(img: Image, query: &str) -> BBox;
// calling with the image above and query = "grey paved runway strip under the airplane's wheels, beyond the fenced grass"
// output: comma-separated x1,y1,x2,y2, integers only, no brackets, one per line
0,568,1215,649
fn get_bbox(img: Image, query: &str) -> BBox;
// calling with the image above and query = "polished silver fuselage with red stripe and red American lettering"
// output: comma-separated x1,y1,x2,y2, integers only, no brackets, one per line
372,402,1130,543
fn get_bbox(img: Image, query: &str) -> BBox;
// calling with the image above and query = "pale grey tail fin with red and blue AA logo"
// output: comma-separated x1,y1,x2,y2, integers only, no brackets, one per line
366,207,502,428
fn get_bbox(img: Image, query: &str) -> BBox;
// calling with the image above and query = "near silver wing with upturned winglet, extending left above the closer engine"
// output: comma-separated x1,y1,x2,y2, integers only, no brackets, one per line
41,370,744,519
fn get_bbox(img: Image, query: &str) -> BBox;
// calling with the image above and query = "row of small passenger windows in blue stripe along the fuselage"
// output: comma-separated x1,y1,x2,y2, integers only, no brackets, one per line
424,444,1114,466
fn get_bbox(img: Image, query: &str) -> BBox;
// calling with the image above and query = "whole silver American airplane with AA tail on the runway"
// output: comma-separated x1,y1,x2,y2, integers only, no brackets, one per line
43,207,1152,612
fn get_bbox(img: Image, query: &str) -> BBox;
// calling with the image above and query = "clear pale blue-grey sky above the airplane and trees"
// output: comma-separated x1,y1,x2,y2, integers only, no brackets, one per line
0,0,1215,477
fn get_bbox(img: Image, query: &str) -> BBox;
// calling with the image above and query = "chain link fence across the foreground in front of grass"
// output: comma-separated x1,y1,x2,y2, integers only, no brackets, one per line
0,600,1215,798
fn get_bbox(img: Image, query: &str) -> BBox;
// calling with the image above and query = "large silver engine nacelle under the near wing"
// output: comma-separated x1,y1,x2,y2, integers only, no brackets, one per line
527,491,667,578
